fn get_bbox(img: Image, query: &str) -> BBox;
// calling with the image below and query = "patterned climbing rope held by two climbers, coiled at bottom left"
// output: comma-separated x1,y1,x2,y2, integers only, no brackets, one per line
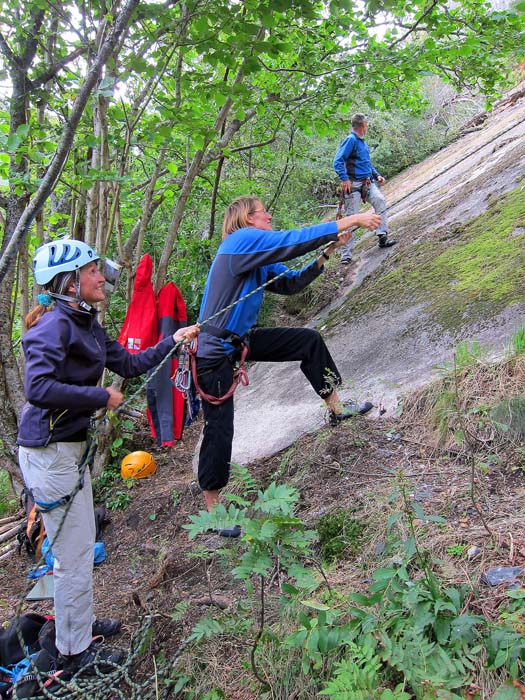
13,232,348,700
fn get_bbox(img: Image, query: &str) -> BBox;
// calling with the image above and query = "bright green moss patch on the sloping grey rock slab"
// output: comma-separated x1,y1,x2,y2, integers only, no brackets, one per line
331,186,525,332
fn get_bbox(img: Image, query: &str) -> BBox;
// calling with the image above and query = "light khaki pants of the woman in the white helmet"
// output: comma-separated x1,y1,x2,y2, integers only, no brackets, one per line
19,442,95,655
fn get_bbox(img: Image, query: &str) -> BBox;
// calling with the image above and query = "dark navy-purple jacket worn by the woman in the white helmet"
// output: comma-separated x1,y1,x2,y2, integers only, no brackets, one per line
17,301,174,447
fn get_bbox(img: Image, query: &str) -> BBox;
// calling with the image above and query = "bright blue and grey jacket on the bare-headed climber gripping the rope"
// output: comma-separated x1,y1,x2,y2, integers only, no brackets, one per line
197,221,337,360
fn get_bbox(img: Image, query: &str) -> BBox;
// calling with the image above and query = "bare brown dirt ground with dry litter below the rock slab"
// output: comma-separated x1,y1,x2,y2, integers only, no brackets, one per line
0,394,525,700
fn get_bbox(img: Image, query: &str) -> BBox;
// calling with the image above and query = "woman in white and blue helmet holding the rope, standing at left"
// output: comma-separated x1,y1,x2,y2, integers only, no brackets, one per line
17,240,199,674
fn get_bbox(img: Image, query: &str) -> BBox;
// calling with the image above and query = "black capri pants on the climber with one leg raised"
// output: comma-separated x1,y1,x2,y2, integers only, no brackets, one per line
197,328,341,491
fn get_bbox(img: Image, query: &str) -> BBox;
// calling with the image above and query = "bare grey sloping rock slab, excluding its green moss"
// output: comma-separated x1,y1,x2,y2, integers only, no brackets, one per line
202,90,525,464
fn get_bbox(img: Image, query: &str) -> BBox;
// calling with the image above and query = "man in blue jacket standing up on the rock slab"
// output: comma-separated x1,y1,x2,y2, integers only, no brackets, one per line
334,114,396,264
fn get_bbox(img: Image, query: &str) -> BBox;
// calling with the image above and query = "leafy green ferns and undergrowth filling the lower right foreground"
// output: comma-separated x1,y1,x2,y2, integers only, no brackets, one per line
180,473,525,700
